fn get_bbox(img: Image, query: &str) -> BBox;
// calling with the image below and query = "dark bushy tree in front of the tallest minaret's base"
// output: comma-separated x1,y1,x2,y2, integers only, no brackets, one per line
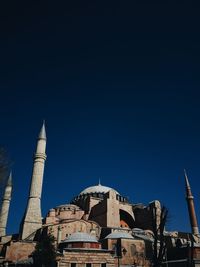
33,234,56,267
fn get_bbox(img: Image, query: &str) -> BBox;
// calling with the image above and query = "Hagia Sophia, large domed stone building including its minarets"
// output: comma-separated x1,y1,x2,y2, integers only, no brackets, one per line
0,123,200,267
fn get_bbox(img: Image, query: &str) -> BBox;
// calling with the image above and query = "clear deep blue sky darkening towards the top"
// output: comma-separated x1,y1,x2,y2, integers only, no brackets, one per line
0,1,200,232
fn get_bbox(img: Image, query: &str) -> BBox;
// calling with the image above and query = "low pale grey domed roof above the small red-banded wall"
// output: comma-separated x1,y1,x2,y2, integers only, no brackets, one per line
63,232,98,243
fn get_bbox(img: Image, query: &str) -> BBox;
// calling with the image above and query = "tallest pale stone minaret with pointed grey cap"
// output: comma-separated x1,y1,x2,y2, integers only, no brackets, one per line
20,123,46,239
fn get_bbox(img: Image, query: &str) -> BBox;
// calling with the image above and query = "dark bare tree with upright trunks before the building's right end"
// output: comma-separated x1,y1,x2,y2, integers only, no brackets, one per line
152,206,168,267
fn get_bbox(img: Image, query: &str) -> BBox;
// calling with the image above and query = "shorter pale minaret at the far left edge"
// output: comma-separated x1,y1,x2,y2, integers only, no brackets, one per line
0,173,12,236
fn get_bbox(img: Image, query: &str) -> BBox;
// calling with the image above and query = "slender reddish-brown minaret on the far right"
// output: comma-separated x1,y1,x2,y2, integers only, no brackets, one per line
184,170,199,235
